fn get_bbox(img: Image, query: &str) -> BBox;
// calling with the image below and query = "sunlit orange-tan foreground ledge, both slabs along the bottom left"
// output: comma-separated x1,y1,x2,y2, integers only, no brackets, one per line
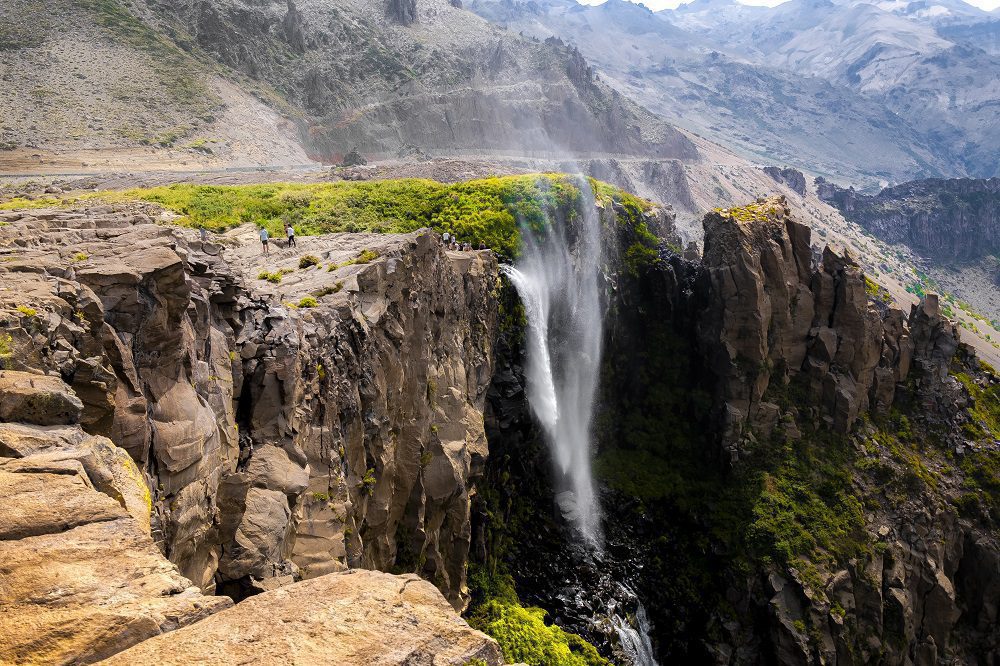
0,370,503,666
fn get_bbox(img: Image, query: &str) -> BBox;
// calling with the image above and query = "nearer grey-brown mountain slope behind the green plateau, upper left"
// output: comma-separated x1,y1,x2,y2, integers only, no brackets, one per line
0,0,693,169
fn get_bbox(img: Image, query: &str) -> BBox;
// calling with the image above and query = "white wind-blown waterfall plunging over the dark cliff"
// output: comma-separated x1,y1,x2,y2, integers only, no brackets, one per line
504,179,605,549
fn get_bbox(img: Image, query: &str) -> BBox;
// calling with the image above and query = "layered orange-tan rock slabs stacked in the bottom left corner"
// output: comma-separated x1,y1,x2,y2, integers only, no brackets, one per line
0,372,231,664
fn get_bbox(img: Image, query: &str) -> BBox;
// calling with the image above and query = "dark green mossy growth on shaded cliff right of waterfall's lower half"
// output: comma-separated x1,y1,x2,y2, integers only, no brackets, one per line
597,364,870,602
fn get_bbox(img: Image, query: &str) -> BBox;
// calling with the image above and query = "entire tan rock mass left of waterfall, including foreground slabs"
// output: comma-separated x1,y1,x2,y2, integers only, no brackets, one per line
0,206,502,664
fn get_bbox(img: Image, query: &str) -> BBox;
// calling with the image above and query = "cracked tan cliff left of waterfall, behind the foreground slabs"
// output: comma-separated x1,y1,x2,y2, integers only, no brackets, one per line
0,207,496,608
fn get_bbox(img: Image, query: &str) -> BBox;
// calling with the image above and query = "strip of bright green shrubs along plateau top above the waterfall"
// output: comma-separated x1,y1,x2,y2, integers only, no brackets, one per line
0,174,656,261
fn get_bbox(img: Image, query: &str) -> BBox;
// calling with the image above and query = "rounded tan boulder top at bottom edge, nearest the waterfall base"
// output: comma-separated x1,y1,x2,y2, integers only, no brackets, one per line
103,571,504,666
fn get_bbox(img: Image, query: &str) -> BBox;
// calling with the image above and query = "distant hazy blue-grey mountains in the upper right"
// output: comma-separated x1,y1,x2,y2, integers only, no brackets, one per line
468,0,1000,187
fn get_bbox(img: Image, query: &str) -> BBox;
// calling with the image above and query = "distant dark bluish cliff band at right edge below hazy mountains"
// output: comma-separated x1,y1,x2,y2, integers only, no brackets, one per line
816,178,1000,261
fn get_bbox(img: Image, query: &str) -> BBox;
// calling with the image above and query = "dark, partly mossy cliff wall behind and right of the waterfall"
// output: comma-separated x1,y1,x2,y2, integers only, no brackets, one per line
477,193,1000,666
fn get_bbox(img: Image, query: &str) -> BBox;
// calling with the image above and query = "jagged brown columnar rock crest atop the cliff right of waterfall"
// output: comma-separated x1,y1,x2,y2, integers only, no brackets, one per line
700,197,958,456
